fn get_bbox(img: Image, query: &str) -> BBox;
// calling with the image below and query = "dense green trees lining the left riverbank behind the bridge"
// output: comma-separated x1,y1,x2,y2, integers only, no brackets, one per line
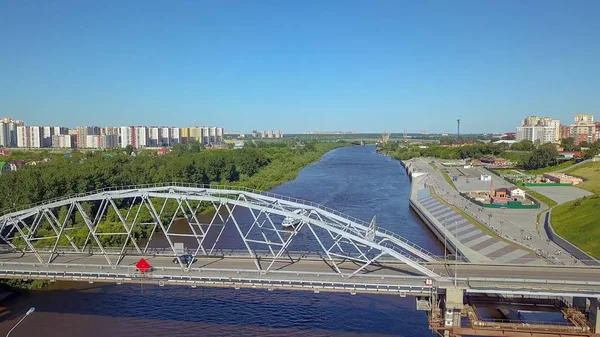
0,142,346,246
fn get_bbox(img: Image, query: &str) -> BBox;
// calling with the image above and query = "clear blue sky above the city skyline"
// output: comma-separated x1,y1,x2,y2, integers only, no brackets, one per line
0,0,600,133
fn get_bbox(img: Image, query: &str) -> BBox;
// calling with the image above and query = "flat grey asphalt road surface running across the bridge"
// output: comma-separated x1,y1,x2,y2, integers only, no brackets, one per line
0,253,600,286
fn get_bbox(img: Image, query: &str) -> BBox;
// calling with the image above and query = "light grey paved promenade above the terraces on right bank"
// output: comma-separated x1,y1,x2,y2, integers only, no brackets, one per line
407,158,577,265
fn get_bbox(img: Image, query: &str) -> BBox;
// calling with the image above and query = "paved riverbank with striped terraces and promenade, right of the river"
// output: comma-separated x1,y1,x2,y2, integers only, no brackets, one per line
400,158,573,265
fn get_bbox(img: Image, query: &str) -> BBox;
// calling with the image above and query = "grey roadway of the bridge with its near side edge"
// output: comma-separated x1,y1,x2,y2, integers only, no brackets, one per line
0,253,600,296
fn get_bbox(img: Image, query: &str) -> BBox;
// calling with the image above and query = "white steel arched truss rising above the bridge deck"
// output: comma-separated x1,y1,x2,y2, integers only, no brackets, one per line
0,183,440,278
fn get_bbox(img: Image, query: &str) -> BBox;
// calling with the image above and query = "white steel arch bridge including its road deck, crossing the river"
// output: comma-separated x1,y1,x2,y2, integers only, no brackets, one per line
0,183,600,297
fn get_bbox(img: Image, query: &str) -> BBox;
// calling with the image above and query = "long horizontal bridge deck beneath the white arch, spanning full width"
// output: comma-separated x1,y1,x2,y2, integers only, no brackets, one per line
0,253,600,296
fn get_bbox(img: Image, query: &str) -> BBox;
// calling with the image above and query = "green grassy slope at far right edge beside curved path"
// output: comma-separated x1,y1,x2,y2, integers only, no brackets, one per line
552,162,600,258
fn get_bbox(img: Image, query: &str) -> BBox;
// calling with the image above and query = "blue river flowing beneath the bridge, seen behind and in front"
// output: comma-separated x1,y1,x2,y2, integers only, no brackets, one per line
0,146,443,337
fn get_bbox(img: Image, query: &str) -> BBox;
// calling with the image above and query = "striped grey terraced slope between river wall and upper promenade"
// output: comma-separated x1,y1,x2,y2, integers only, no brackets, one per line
417,188,545,265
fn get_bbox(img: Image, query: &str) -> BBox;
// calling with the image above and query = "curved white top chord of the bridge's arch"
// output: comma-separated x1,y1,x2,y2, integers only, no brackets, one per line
2,182,439,259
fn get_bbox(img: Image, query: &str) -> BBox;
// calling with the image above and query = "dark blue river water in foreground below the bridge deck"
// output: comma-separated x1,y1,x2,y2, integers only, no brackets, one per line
0,283,431,336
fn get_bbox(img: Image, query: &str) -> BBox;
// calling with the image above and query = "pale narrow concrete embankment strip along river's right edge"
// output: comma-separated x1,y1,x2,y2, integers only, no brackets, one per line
401,161,491,262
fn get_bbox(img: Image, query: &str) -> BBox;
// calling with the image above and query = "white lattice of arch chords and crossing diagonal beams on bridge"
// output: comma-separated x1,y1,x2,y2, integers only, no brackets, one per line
0,185,438,277
